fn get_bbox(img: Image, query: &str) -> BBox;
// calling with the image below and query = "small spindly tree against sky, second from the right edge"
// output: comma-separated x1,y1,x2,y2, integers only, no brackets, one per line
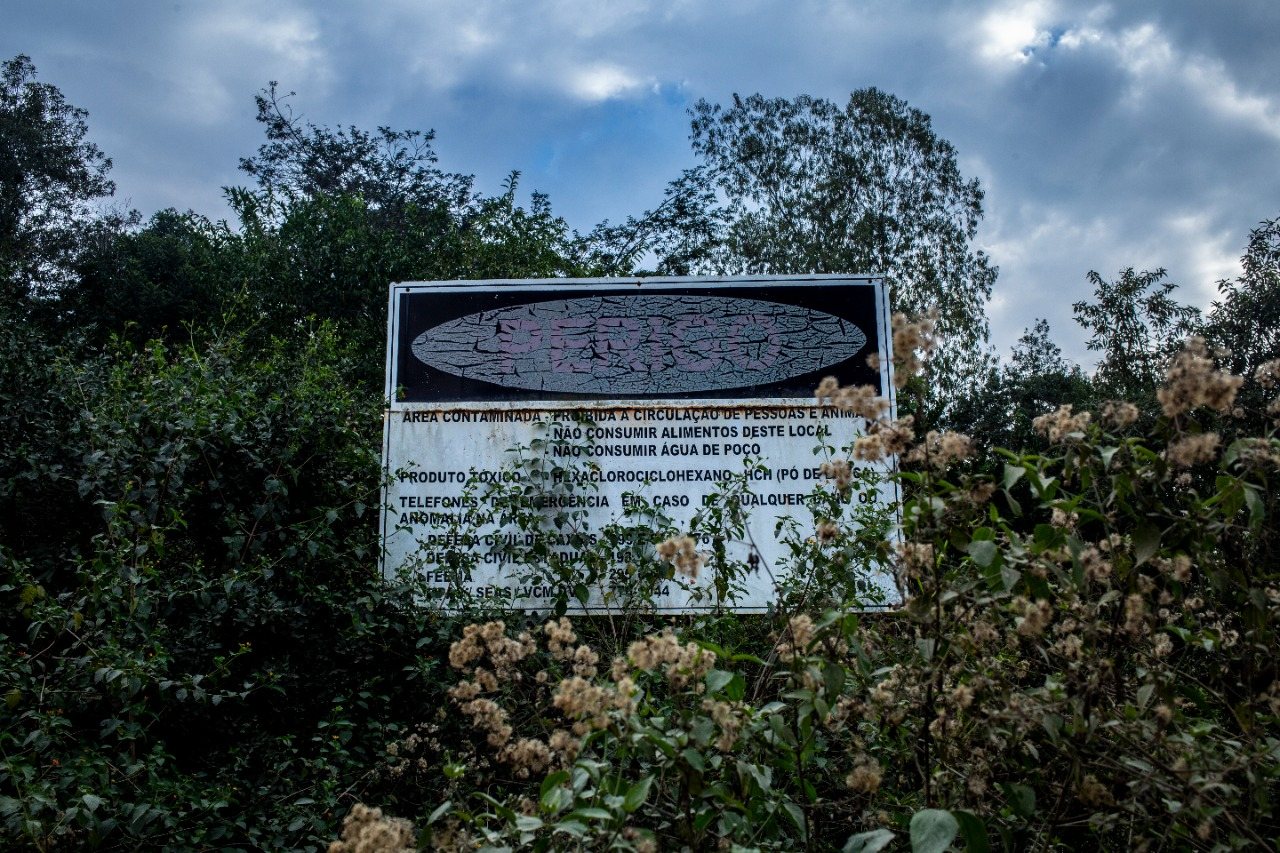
1071,266,1199,402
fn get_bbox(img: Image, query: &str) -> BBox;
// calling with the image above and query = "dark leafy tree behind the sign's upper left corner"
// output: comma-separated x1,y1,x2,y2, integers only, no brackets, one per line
228,83,595,388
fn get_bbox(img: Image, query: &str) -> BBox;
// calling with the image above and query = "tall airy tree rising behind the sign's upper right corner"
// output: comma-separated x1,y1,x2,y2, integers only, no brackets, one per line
596,88,997,392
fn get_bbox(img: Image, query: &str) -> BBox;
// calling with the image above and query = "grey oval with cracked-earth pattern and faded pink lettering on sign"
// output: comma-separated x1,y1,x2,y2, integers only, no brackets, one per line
412,295,867,396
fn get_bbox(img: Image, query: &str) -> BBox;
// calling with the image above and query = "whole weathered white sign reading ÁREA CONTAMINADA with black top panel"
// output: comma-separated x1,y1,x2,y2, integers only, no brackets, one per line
383,275,896,611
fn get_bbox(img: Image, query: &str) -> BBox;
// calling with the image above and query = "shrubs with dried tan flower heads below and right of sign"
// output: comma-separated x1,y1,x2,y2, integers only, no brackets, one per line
335,326,1280,850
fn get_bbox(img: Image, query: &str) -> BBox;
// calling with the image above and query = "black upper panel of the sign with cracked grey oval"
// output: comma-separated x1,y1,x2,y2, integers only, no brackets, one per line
394,282,883,402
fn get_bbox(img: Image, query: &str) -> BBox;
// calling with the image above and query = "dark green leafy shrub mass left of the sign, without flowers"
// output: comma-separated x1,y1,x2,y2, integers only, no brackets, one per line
0,327,422,848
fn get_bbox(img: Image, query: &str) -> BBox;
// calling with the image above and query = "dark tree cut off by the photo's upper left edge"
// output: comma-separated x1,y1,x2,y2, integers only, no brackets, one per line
0,54,115,306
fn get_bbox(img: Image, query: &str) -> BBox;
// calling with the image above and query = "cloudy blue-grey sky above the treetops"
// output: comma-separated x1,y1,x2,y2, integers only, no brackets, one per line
10,0,1280,366
